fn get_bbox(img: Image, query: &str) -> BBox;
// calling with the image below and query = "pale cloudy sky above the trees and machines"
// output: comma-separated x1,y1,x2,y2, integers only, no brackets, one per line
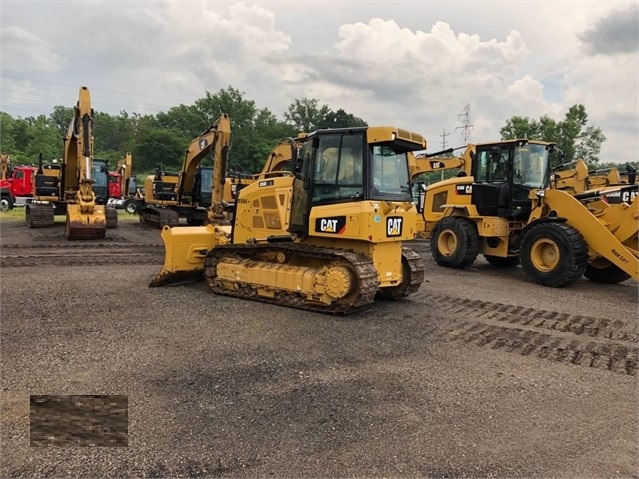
0,0,639,161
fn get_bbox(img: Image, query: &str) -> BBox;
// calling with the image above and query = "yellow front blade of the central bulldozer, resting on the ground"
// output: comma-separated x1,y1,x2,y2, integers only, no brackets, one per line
149,225,217,287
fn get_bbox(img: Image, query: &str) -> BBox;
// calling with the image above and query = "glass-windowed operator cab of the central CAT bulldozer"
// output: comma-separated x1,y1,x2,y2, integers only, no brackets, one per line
290,127,416,236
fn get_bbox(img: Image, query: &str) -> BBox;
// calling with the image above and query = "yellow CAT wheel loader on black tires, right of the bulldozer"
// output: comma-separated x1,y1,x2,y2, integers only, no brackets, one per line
420,140,639,287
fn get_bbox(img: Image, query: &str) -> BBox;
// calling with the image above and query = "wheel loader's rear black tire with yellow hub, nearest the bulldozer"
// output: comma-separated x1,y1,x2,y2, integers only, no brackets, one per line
430,216,481,269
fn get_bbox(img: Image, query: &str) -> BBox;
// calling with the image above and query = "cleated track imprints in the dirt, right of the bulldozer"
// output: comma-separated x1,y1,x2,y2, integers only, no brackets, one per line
413,293,638,376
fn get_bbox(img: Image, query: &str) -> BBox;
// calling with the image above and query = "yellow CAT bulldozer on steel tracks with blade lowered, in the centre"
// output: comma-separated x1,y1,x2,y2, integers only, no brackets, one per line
150,115,426,314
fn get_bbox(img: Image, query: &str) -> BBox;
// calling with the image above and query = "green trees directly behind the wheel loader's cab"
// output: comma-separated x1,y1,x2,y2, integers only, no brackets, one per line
500,104,606,166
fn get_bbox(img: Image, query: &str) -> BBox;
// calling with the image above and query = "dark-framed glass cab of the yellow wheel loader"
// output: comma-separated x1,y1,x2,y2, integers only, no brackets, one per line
472,140,554,221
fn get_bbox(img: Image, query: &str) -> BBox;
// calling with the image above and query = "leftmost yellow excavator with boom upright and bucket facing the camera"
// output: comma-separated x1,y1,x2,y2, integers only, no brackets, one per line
26,86,107,240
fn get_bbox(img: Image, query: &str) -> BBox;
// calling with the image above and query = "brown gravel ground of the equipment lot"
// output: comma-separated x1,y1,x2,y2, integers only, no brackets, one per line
0,216,639,478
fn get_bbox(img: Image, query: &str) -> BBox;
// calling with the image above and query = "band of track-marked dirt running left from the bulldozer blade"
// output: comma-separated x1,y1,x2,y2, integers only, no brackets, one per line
0,242,164,268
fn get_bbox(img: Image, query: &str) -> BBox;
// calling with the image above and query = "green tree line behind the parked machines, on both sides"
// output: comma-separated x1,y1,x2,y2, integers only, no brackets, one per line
0,86,605,180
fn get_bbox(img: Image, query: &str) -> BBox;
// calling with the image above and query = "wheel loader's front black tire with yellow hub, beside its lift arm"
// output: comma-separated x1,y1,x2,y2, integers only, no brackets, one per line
520,222,588,288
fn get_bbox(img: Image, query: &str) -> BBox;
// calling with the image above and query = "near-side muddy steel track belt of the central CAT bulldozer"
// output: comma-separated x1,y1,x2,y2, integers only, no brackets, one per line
204,244,379,314
